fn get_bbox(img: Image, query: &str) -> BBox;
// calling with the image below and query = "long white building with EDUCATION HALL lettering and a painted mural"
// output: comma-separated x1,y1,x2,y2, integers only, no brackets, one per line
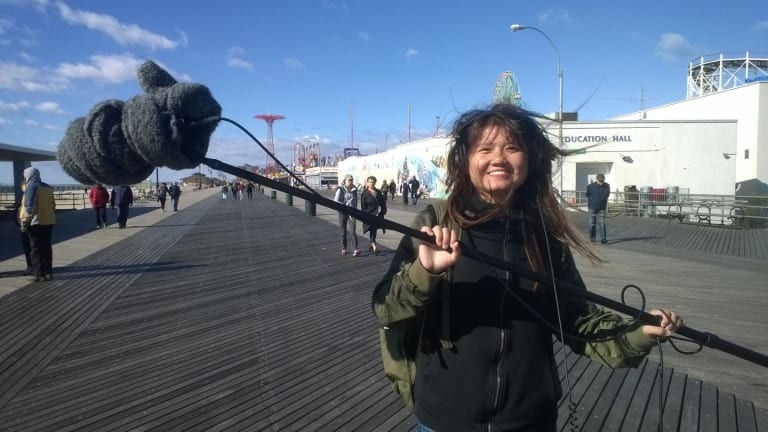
339,54,768,197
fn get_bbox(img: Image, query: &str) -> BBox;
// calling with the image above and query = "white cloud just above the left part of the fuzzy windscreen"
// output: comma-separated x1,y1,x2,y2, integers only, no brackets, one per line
56,55,144,83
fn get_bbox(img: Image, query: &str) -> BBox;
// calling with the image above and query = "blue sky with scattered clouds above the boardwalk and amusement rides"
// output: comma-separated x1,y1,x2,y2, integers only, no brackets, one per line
0,0,768,184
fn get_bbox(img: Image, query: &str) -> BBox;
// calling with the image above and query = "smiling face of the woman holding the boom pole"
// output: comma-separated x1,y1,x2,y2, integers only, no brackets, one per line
469,126,528,204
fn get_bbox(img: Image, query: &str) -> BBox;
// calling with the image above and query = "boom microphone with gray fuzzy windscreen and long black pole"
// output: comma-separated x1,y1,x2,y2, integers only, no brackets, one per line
57,61,768,367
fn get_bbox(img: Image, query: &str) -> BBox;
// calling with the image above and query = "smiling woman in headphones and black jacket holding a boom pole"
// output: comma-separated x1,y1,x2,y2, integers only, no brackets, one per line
373,104,683,431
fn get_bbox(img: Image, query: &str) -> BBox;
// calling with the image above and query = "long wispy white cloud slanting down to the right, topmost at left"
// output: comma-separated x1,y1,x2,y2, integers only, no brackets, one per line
56,2,180,49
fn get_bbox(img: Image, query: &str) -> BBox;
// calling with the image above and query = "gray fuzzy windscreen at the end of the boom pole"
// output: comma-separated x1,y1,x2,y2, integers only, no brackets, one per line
57,61,221,185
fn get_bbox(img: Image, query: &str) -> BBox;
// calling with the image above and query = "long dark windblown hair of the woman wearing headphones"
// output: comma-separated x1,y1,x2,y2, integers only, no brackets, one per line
445,104,602,280
